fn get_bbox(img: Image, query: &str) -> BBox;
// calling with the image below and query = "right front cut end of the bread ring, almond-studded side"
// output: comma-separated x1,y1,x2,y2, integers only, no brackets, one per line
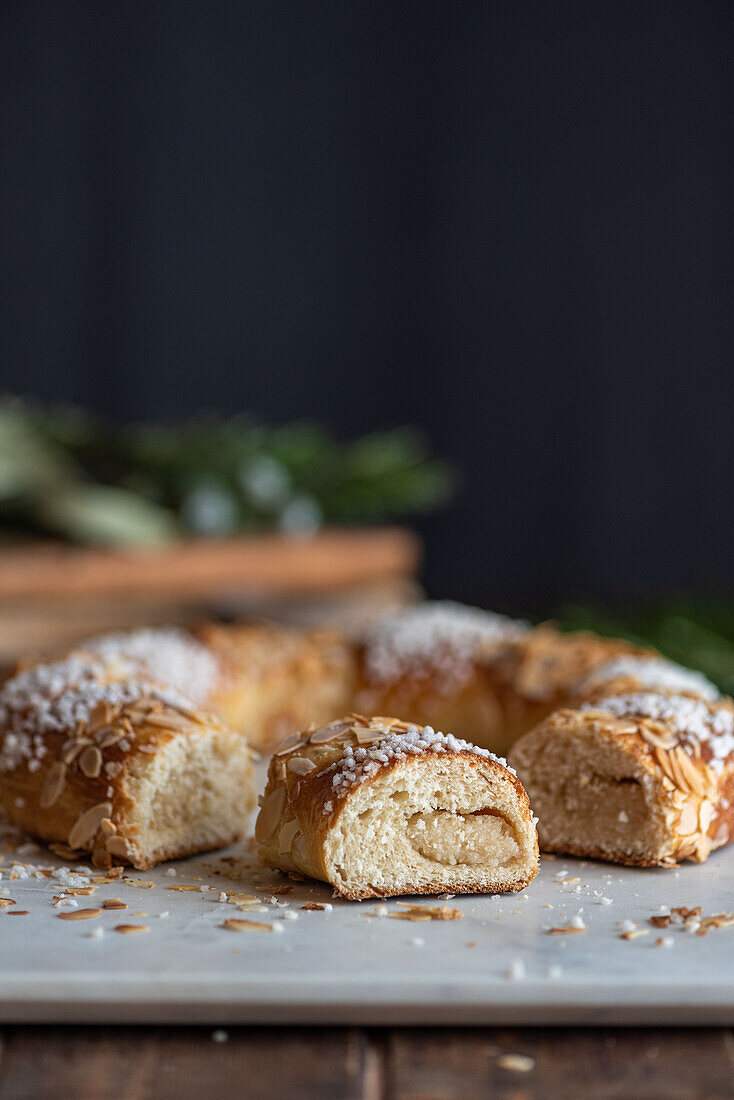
510,692,734,867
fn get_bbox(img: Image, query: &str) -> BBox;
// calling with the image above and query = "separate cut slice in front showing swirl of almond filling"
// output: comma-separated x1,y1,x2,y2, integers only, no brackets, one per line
255,715,538,900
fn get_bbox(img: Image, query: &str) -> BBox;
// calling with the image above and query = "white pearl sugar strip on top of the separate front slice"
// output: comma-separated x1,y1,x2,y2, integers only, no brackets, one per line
324,726,516,814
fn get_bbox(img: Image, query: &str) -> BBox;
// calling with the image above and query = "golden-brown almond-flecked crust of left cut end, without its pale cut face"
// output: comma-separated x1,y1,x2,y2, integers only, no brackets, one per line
0,657,254,869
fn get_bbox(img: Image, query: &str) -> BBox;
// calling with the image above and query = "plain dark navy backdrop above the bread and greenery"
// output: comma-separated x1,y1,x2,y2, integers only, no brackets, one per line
0,0,734,609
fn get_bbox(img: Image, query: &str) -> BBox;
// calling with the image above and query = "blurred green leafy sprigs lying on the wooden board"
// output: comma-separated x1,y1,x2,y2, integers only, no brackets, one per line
0,398,454,547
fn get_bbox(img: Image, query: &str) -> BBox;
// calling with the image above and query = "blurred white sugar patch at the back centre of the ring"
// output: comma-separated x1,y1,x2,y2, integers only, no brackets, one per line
365,601,528,686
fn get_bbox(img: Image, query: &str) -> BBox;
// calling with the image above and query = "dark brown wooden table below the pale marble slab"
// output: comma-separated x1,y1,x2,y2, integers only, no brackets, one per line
0,1026,734,1100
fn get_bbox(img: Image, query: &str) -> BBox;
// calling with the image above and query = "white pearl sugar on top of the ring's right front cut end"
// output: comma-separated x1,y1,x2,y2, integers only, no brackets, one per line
581,692,734,772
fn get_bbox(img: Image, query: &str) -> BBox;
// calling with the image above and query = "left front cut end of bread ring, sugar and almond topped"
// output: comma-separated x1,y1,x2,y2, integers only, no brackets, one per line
0,653,254,870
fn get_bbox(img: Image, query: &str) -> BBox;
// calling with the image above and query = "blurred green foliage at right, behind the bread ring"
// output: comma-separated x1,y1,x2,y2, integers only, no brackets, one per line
554,596,734,695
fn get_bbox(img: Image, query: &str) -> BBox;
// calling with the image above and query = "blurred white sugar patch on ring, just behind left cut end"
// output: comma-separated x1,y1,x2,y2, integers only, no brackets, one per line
84,627,219,703
